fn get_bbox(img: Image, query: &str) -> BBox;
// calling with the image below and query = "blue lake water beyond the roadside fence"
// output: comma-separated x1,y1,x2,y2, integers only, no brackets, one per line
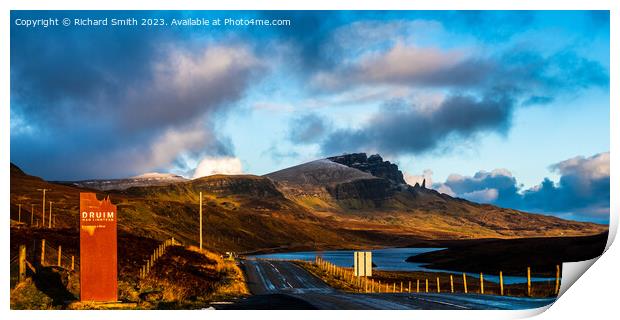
250,248,555,284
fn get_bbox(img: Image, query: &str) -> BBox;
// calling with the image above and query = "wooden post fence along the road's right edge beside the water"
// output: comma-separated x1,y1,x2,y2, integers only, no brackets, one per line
314,256,560,297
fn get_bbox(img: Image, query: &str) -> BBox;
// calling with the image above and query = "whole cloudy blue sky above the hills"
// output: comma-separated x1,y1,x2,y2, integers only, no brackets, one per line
10,11,610,223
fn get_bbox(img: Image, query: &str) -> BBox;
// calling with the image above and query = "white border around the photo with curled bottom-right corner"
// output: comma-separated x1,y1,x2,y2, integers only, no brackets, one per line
0,0,620,320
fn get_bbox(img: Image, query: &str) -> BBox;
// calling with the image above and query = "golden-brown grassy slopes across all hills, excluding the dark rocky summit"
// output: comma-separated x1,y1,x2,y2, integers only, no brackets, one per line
11,166,607,252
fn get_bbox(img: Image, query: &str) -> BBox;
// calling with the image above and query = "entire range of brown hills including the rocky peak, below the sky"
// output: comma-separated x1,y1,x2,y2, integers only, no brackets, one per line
11,154,607,252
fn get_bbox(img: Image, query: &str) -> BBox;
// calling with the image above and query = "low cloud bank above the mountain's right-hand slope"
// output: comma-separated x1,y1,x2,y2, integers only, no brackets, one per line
433,152,610,222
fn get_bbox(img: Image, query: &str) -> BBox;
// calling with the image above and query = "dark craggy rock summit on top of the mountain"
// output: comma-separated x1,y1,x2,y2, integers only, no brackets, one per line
327,153,407,186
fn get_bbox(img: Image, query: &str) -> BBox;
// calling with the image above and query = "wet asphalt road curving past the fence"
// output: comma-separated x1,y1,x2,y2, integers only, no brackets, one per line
215,260,554,310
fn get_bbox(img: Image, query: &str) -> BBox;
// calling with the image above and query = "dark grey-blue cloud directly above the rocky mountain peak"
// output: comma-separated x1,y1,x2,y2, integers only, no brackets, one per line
321,93,514,154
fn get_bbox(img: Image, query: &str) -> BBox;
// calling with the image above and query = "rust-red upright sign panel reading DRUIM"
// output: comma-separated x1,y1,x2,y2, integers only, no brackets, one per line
80,192,118,302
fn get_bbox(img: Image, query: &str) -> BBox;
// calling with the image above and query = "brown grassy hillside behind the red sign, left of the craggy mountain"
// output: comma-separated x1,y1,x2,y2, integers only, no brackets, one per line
10,165,410,252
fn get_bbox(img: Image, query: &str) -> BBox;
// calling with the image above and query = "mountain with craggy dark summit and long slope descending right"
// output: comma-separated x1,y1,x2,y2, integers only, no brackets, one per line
265,153,606,239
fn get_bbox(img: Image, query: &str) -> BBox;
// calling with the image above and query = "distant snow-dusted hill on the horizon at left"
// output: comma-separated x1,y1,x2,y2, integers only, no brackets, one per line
61,172,187,191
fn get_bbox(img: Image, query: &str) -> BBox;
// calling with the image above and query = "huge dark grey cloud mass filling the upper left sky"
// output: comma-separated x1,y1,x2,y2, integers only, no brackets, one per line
11,12,264,179
